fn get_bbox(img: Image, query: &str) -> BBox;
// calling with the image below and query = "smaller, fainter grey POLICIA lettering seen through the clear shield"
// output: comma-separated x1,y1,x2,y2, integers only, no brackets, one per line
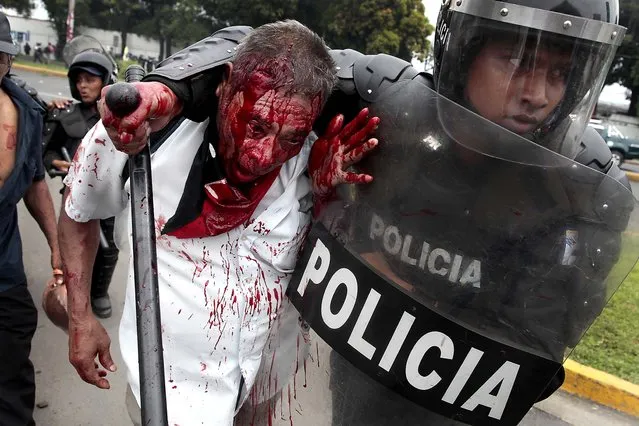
369,214,481,288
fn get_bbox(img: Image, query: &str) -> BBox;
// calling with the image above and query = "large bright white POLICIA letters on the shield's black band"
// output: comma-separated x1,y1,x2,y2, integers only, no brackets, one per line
297,238,519,419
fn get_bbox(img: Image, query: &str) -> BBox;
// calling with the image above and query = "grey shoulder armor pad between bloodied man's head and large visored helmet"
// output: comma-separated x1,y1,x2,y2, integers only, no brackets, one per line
353,53,419,102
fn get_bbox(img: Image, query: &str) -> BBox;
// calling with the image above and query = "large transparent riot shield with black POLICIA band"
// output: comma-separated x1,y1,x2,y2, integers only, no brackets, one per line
236,81,639,426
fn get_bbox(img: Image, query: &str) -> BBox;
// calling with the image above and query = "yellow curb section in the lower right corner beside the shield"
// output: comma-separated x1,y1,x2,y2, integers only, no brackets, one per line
561,359,639,417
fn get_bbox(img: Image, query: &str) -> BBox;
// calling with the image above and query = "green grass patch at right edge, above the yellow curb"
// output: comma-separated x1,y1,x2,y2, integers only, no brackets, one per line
570,267,639,384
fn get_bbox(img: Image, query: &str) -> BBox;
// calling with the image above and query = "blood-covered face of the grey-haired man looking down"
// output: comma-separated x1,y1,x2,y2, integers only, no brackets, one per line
217,71,319,184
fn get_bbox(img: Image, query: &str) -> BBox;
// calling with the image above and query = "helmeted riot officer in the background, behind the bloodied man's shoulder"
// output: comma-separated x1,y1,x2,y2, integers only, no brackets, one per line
44,51,118,318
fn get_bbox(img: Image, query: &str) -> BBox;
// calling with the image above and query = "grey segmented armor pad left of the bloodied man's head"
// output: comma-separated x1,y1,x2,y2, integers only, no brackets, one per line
147,26,253,81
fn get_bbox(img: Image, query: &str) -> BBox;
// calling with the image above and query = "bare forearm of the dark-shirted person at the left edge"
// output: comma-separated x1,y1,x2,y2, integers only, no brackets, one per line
24,179,62,284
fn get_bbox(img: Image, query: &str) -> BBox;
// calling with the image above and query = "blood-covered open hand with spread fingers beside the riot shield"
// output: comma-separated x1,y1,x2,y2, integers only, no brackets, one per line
308,108,379,211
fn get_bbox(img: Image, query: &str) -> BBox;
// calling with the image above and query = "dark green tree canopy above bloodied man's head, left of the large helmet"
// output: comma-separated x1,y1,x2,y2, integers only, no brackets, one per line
200,0,433,61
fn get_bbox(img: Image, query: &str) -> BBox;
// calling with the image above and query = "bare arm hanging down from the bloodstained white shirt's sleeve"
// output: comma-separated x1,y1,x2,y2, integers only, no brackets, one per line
58,188,116,389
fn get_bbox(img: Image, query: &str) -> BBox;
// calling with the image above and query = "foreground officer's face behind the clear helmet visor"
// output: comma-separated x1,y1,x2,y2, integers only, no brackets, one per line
466,41,571,134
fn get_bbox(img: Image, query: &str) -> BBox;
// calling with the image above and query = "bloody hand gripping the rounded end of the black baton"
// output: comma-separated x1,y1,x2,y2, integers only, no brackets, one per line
98,82,182,154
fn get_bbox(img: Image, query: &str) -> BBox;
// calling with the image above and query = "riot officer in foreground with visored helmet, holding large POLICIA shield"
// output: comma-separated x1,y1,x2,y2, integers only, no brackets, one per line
82,0,636,425
